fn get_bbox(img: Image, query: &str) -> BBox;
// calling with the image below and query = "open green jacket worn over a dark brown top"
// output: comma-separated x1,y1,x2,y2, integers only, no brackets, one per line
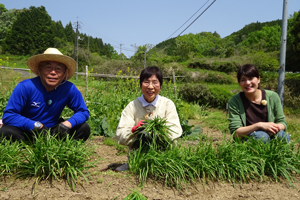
228,90,287,133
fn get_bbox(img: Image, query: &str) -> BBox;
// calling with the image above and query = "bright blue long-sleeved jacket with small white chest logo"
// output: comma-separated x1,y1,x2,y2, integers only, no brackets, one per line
3,76,89,130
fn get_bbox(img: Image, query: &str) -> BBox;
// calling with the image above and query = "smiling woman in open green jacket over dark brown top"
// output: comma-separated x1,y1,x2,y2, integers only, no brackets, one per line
228,64,290,143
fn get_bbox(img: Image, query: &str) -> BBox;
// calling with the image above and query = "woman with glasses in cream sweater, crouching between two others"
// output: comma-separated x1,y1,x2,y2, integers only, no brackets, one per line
115,66,182,171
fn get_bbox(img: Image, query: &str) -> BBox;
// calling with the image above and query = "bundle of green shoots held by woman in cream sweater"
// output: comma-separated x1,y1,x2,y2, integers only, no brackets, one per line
133,116,172,151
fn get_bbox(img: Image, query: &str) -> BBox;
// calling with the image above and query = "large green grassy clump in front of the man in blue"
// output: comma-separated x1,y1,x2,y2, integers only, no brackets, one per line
17,134,94,191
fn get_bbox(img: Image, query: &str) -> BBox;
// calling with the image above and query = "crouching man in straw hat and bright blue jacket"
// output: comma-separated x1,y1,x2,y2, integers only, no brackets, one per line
0,48,90,141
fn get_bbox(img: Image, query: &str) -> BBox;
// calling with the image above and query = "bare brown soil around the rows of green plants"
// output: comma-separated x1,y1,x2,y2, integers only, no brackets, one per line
0,128,300,200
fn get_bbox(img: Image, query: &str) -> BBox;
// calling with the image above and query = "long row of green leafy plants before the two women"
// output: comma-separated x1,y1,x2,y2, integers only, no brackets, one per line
129,136,300,190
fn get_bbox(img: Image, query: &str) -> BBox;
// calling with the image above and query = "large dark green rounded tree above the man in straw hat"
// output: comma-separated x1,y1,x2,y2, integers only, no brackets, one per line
3,6,54,55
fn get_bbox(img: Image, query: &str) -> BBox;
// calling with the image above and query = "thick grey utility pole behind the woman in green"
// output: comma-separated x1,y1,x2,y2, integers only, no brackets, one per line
277,0,288,107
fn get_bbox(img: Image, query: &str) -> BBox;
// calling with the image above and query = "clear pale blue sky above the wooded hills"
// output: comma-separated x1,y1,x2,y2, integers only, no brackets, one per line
1,0,300,57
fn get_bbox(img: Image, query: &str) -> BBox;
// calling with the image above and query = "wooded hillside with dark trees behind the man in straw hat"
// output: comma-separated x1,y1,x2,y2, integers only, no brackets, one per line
0,4,115,58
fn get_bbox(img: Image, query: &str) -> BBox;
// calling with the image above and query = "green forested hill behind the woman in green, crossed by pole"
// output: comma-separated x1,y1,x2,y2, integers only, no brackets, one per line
149,12,300,71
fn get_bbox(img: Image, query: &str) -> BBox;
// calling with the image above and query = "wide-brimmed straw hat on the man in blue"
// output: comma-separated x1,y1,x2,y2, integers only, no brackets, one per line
27,48,76,80
